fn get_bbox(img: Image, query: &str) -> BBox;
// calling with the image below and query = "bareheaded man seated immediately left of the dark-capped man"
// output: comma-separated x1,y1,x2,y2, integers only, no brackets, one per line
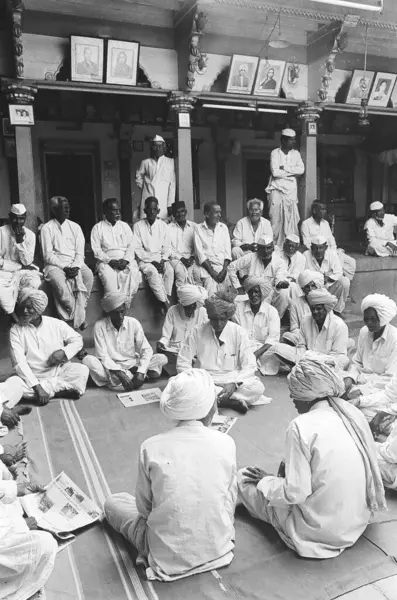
168,202,201,288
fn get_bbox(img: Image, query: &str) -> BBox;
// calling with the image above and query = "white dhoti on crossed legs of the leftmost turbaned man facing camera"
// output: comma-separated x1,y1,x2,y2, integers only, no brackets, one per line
23,362,89,399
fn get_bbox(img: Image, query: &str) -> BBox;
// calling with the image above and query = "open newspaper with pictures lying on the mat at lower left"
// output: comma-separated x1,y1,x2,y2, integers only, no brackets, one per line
20,472,102,542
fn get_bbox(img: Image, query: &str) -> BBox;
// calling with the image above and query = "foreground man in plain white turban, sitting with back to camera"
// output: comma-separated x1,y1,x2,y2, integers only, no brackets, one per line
104,369,237,581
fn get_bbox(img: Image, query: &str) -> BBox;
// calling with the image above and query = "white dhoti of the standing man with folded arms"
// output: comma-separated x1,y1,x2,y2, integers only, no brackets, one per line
268,190,299,248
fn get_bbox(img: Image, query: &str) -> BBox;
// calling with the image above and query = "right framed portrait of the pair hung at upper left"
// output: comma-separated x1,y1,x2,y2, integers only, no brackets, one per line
106,40,139,85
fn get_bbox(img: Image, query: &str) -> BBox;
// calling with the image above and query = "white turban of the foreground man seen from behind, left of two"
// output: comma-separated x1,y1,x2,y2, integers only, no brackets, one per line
160,369,216,421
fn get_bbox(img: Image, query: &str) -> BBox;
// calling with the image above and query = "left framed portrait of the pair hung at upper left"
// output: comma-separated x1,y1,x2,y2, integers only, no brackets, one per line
70,35,104,83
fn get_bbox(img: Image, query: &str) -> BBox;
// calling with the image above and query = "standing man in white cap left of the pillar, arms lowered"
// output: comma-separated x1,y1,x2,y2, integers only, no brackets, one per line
135,135,175,220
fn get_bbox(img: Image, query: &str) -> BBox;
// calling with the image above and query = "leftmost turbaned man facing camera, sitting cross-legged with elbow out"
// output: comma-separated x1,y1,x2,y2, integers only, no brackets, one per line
10,288,88,406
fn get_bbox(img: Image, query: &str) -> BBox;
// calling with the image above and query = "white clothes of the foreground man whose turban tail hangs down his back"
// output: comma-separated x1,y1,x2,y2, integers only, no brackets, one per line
238,401,371,558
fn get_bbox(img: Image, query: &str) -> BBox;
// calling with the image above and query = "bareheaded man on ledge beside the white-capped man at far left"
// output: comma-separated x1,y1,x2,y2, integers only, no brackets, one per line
41,196,94,329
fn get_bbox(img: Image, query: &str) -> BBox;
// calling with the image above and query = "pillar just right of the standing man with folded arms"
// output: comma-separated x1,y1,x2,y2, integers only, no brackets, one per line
297,101,322,221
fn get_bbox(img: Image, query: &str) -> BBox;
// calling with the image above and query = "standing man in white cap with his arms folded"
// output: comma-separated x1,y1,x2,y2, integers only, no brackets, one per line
266,129,305,246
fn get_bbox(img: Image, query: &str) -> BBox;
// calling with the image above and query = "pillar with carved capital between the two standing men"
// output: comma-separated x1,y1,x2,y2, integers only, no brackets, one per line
168,94,196,220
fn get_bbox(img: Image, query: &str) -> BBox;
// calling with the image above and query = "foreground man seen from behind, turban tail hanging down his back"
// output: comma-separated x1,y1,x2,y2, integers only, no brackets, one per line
238,359,386,559
